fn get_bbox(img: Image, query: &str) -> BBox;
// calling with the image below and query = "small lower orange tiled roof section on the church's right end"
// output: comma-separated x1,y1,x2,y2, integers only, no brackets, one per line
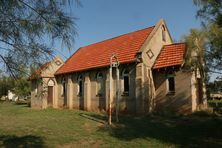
153,43,186,69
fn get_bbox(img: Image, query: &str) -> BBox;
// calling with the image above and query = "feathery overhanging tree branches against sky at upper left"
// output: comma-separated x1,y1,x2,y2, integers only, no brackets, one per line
0,0,80,76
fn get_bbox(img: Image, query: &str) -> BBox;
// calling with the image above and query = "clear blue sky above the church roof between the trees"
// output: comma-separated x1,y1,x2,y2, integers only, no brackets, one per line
55,0,200,60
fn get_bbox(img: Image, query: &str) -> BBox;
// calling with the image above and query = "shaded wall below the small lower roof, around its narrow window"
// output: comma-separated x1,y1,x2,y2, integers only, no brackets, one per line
153,71,192,113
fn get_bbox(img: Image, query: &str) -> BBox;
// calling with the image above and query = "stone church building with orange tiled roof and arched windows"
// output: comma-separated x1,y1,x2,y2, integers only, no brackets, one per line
31,19,206,114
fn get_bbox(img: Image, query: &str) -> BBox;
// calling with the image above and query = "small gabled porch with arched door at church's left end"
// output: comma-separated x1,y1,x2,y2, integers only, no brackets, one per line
29,56,64,108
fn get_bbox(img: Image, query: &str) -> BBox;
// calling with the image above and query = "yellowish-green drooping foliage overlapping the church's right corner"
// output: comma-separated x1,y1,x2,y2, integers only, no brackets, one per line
184,29,209,100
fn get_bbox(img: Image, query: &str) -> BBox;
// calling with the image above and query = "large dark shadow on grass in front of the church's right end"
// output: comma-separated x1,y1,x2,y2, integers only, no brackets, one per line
87,114,222,147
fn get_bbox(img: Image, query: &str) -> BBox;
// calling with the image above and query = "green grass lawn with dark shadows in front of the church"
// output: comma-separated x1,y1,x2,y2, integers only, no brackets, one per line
0,102,222,147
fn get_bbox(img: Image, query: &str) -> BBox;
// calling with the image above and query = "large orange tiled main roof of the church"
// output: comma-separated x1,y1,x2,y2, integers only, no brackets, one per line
56,27,154,75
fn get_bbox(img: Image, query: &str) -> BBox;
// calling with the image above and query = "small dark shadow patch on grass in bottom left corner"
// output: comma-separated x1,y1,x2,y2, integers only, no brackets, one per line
0,135,44,148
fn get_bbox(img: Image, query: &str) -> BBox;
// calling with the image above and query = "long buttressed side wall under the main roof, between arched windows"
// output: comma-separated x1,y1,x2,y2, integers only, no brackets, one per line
56,63,136,112
